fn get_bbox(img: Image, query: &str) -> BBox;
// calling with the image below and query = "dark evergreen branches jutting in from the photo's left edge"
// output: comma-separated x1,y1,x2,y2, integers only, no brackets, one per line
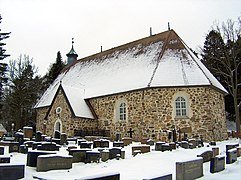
0,15,10,105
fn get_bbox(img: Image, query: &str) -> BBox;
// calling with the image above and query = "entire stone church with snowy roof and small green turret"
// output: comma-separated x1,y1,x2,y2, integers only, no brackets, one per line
35,30,227,141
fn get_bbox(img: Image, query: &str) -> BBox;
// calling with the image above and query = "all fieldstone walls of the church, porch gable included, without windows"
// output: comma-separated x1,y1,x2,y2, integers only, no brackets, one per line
37,86,227,141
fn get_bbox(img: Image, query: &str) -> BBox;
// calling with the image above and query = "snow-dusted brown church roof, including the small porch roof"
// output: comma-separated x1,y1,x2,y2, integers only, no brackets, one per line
35,30,227,118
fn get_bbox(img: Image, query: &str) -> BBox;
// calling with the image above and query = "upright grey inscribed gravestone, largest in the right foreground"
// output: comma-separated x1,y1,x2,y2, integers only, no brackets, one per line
176,157,203,180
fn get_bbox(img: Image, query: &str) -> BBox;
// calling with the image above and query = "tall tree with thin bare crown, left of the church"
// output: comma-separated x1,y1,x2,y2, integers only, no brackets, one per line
4,56,41,129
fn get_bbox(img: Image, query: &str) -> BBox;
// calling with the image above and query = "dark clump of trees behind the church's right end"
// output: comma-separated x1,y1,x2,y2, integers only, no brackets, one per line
202,19,241,132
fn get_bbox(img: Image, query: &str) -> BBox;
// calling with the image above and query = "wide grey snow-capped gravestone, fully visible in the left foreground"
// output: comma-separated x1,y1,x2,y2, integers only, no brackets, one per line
36,154,73,172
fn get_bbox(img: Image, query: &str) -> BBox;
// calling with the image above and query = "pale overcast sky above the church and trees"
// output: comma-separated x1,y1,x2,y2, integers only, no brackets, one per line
0,0,241,75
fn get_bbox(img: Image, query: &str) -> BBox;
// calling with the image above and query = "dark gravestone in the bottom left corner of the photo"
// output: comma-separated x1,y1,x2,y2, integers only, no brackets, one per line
0,164,25,180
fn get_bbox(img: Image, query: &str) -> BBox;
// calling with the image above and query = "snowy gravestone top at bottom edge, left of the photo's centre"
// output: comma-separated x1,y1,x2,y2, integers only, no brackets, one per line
76,172,120,180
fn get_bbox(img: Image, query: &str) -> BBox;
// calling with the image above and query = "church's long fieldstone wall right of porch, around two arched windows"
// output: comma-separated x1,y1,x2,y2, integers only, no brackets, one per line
90,87,227,141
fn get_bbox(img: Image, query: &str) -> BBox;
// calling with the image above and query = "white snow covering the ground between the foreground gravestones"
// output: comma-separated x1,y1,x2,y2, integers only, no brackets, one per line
5,139,241,180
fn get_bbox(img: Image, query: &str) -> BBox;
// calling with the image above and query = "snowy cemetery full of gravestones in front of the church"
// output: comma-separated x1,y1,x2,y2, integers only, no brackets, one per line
0,128,241,180
